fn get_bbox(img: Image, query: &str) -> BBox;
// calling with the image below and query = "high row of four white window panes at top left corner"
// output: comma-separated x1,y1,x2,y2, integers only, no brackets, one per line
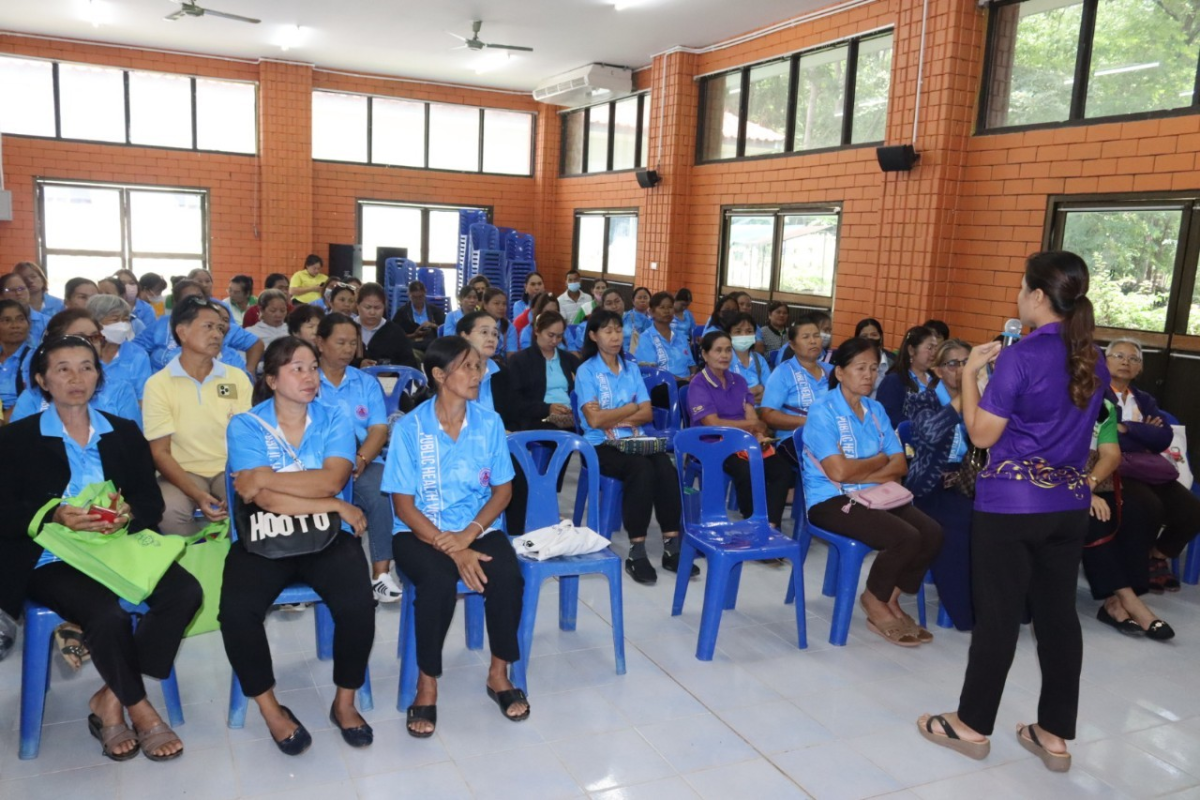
0,55,258,155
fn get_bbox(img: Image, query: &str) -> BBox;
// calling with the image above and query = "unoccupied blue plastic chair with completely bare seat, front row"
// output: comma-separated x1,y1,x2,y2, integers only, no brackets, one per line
671,427,808,661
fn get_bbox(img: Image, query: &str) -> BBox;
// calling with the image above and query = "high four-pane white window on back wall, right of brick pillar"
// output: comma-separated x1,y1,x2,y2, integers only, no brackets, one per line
312,90,538,178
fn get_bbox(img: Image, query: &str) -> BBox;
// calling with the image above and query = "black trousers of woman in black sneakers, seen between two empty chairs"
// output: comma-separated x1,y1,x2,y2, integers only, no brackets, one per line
596,445,680,541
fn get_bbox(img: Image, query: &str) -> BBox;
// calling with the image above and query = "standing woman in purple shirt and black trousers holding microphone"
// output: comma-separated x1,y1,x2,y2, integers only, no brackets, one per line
917,252,1109,772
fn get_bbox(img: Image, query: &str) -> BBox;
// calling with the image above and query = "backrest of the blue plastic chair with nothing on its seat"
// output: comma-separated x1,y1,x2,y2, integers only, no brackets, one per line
674,426,767,525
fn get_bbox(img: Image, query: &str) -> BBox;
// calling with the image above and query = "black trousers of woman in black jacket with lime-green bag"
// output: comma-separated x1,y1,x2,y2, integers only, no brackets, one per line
29,561,204,708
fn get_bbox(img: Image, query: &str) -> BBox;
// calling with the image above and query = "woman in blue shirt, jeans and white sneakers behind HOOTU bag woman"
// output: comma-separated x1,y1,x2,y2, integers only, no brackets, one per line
317,312,400,603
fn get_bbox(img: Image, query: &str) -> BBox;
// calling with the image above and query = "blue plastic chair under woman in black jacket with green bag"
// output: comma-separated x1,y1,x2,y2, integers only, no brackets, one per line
19,600,184,760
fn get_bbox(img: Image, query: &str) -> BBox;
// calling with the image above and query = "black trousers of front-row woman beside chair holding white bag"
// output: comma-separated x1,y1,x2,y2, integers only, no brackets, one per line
391,530,524,678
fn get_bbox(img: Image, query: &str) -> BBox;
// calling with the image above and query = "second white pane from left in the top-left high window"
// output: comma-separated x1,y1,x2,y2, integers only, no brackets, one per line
59,64,125,142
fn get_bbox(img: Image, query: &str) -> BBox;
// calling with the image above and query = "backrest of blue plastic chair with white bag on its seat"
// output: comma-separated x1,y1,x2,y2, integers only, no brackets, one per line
509,431,604,535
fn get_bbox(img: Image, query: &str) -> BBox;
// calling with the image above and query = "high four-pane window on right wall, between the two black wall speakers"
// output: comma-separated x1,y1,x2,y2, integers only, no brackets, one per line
696,31,893,163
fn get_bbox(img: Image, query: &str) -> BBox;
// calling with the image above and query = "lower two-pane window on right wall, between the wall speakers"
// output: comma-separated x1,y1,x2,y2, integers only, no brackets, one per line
720,205,841,308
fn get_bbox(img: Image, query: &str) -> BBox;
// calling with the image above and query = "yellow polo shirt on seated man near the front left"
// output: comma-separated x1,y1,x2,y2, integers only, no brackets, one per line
142,356,253,477
